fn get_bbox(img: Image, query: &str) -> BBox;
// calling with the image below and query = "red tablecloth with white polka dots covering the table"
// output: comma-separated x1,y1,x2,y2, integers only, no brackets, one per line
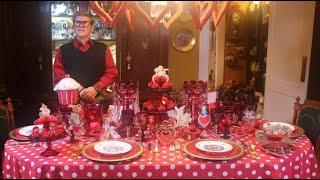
2,135,319,179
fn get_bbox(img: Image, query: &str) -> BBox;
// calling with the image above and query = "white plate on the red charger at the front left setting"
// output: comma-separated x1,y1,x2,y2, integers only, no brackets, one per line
93,140,132,155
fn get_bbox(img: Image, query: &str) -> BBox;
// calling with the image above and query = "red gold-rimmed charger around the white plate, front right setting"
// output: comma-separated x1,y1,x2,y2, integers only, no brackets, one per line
183,139,244,161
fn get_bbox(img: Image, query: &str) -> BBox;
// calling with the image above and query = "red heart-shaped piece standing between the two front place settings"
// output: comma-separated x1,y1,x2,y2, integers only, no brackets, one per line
156,126,176,145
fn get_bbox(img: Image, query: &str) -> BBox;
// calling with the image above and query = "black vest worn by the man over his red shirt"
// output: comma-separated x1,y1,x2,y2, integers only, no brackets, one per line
60,41,106,88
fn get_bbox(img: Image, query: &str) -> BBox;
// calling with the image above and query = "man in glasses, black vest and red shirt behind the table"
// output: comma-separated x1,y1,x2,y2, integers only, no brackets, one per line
53,11,118,101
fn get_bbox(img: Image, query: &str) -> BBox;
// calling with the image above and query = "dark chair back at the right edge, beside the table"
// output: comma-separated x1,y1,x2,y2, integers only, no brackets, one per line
293,97,320,146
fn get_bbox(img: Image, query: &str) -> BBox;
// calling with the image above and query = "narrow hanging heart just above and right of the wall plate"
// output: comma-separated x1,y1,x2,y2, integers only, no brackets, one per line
187,1,216,31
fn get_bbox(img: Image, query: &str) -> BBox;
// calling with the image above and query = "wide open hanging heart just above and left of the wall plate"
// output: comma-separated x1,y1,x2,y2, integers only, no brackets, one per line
132,2,170,27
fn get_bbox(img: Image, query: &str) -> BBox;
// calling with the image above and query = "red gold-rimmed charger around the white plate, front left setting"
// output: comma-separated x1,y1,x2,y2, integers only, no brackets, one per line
82,140,143,162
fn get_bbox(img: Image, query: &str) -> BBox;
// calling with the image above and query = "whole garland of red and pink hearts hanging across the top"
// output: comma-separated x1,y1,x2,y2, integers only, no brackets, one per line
89,1,230,31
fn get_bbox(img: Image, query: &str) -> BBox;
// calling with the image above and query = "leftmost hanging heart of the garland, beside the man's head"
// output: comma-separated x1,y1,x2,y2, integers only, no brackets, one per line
89,1,124,27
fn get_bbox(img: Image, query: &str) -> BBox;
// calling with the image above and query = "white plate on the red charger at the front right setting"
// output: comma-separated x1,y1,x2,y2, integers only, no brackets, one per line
195,141,233,153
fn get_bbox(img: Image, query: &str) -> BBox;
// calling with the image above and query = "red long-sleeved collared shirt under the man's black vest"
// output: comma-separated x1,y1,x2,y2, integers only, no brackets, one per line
53,39,118,91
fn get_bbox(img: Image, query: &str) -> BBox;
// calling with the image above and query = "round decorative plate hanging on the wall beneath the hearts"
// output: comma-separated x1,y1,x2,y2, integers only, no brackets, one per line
172,29,196,52
